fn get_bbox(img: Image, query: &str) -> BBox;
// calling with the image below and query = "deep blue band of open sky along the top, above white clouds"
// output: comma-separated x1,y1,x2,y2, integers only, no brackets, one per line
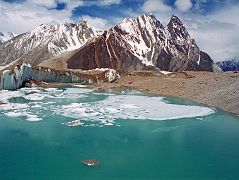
0,0,239,21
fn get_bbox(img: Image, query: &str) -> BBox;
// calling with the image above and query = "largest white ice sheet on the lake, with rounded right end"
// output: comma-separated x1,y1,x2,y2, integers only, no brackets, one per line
55,95,215,121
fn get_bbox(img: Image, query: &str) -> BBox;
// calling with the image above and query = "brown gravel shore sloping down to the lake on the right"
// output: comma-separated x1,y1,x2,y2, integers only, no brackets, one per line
87,72,239,115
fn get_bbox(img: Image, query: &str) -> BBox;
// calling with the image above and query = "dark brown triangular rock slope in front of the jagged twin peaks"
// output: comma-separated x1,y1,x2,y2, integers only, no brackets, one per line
67,32,144,70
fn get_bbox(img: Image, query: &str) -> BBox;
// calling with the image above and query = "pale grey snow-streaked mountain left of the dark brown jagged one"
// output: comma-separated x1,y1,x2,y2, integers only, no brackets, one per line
0,21,101,65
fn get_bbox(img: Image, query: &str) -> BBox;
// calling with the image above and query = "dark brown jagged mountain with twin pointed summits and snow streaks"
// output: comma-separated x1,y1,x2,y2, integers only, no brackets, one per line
67,14,214,71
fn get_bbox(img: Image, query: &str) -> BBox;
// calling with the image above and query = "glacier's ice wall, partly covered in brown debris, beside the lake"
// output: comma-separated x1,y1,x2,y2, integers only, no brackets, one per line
0,63,119,90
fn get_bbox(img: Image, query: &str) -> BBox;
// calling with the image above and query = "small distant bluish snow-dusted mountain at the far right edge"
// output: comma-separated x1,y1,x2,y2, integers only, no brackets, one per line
217,58,239,72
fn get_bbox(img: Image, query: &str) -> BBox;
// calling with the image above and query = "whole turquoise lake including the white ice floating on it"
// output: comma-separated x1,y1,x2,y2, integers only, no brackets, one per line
0,88,239,180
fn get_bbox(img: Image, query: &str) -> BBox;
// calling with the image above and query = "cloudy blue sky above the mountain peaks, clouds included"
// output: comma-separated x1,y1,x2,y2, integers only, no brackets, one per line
0,0,239,61
